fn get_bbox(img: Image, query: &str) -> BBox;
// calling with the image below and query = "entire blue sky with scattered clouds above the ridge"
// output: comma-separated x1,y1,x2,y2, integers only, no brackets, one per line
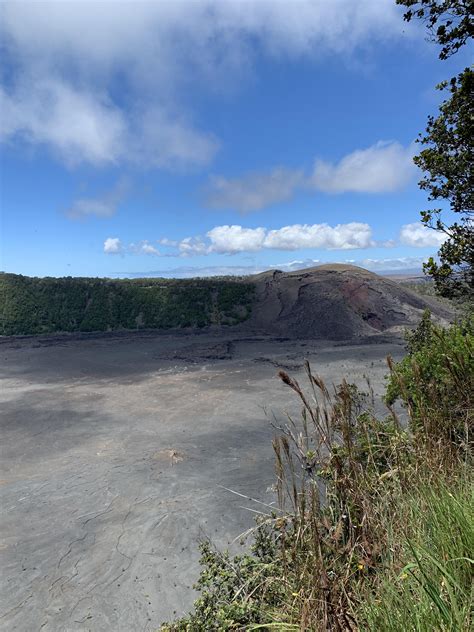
0,0,469,277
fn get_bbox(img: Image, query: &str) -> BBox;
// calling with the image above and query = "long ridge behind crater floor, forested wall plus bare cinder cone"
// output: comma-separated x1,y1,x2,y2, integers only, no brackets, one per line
0,264,452,340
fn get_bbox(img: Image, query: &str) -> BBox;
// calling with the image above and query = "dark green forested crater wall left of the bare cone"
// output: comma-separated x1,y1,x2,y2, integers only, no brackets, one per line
0,274,254,335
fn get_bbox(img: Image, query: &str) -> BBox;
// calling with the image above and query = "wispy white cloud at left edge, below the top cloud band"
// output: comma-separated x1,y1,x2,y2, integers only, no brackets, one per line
0,80,219,168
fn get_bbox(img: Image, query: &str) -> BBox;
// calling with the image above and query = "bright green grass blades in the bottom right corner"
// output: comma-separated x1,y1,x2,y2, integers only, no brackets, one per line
356,480,474,632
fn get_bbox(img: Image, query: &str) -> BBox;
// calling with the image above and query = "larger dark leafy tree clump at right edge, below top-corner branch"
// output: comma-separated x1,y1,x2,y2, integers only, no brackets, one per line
414,68,474,301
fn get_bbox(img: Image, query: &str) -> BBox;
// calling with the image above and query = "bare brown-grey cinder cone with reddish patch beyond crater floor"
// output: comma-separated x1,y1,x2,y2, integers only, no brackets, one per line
249,264,452,340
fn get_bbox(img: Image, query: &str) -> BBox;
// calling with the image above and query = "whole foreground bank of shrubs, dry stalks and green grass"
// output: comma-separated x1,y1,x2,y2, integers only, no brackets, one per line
162,314,474,632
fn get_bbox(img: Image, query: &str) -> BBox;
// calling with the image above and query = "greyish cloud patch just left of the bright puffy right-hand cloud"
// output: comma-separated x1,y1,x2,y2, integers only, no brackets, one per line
206,167,303,213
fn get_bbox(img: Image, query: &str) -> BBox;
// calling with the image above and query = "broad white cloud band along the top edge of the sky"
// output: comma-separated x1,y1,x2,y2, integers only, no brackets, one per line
2,0,406,75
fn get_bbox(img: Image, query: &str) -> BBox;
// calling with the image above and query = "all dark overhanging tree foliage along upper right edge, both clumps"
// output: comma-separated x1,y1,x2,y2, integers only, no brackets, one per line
397,0,474,303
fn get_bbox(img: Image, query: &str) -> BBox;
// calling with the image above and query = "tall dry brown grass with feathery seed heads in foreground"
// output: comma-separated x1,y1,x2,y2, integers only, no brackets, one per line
274,364,411,630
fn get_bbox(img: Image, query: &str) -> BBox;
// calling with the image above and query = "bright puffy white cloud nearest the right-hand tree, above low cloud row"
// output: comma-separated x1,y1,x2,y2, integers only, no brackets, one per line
311,141,415,193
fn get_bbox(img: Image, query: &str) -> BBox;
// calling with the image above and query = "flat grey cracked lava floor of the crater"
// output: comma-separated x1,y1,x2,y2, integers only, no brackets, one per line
0,334,403,632
